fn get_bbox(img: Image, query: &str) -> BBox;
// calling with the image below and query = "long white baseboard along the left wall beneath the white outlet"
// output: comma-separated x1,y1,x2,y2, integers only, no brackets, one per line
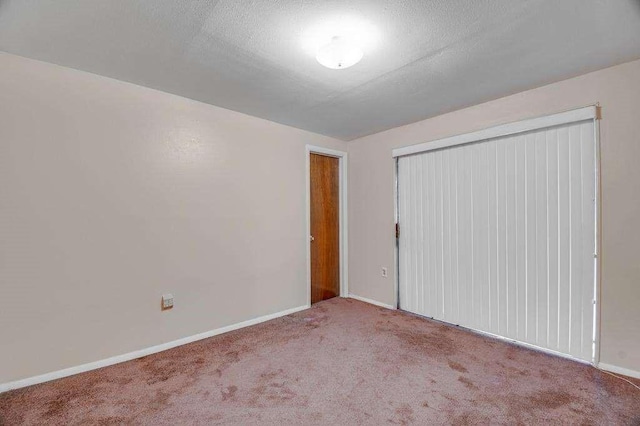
0,305,310,393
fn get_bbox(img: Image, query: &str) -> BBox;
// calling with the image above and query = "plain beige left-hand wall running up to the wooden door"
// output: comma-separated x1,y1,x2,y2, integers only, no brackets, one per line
0,54,346,383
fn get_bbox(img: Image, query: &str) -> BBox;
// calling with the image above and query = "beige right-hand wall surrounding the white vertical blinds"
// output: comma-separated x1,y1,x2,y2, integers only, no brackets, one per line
349,61,640,371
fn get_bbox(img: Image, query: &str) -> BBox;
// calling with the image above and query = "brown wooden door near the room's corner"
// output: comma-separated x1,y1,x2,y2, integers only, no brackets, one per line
309,154,340,303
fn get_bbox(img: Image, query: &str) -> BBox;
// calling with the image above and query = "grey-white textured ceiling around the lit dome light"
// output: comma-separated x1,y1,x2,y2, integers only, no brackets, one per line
0,0,640,140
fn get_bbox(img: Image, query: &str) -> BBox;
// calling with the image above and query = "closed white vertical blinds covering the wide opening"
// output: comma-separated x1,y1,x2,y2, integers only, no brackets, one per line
397,115,597,361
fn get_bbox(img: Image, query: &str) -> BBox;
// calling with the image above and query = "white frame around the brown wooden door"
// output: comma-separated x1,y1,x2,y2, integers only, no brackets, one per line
305,145,349,306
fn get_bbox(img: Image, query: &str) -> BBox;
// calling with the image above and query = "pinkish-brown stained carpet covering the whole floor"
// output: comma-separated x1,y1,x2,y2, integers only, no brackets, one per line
0,299,640,425
